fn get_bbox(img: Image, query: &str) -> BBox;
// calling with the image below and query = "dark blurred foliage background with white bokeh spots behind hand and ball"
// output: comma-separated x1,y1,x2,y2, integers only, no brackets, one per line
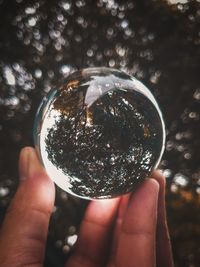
0,0,200,267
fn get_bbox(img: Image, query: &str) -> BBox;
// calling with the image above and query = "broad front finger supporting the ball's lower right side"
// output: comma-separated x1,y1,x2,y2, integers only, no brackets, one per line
115,179,159,267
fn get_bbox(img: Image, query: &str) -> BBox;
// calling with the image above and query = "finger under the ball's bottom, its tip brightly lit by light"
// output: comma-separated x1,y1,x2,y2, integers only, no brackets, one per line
66,198,120,267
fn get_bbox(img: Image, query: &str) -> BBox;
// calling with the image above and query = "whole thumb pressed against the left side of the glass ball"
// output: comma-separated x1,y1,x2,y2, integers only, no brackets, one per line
0,147,55,267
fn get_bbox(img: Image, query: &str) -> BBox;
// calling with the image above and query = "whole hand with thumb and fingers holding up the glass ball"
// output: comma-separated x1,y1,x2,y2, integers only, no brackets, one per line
0,148,173,267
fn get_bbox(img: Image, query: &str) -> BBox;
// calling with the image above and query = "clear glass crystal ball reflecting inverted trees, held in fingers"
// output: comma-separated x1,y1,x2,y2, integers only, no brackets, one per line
34,67,165,199
